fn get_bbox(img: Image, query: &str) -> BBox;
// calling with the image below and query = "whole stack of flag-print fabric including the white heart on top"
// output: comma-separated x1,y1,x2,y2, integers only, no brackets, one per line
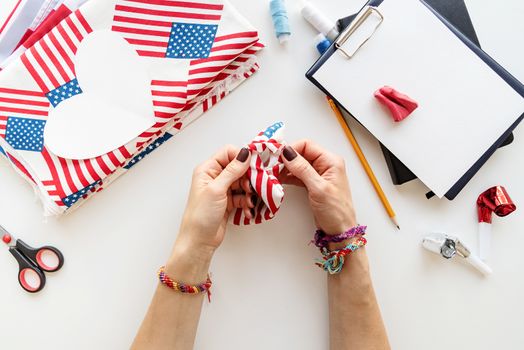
0,0,263,215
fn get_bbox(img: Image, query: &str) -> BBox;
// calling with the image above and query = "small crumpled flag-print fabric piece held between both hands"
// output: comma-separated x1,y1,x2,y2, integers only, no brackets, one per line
232,122,284,225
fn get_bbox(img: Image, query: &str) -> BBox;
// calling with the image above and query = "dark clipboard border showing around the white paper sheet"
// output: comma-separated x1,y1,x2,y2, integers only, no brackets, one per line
306,0,524,200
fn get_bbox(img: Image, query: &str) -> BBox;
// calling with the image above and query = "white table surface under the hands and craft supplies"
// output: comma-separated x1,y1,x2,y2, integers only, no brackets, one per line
0,0,524,350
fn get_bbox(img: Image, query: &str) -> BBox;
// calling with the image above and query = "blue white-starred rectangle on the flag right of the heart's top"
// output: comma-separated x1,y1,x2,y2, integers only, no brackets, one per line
166,23,218,59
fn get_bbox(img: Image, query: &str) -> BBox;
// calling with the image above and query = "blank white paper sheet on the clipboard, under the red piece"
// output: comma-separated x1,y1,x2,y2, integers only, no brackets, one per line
314,0,524,197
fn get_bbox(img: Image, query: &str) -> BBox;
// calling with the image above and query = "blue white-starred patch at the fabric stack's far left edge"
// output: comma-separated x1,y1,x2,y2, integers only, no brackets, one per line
5,117,45,152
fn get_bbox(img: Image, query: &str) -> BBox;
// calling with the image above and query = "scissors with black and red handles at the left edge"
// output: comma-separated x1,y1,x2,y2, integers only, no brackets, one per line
0,226,64,293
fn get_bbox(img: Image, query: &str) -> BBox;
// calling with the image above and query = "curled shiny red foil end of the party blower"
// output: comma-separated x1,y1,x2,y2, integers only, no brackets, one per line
477,186,517,224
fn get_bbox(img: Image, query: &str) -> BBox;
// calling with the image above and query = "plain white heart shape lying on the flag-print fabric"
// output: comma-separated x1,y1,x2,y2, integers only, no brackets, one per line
44,31,155,159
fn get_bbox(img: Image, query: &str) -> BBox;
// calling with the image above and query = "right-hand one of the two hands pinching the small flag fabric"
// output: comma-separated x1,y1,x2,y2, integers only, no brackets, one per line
280,140,356,235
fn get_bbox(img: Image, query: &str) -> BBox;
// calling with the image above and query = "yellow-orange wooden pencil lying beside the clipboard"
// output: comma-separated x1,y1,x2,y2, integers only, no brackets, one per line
327,97,400,230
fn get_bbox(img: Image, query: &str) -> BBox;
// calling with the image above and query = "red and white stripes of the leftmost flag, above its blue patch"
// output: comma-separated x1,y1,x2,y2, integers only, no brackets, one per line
0,87,50,137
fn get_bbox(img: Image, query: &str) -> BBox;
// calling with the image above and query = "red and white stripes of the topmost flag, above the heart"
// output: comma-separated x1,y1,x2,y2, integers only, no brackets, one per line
111,0,224,58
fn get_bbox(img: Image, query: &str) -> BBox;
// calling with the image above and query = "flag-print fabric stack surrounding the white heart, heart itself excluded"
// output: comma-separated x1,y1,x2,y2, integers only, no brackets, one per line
0,0,263,215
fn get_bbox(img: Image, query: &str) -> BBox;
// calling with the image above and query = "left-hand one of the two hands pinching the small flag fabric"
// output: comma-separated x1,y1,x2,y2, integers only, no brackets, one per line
175,146,254,254
